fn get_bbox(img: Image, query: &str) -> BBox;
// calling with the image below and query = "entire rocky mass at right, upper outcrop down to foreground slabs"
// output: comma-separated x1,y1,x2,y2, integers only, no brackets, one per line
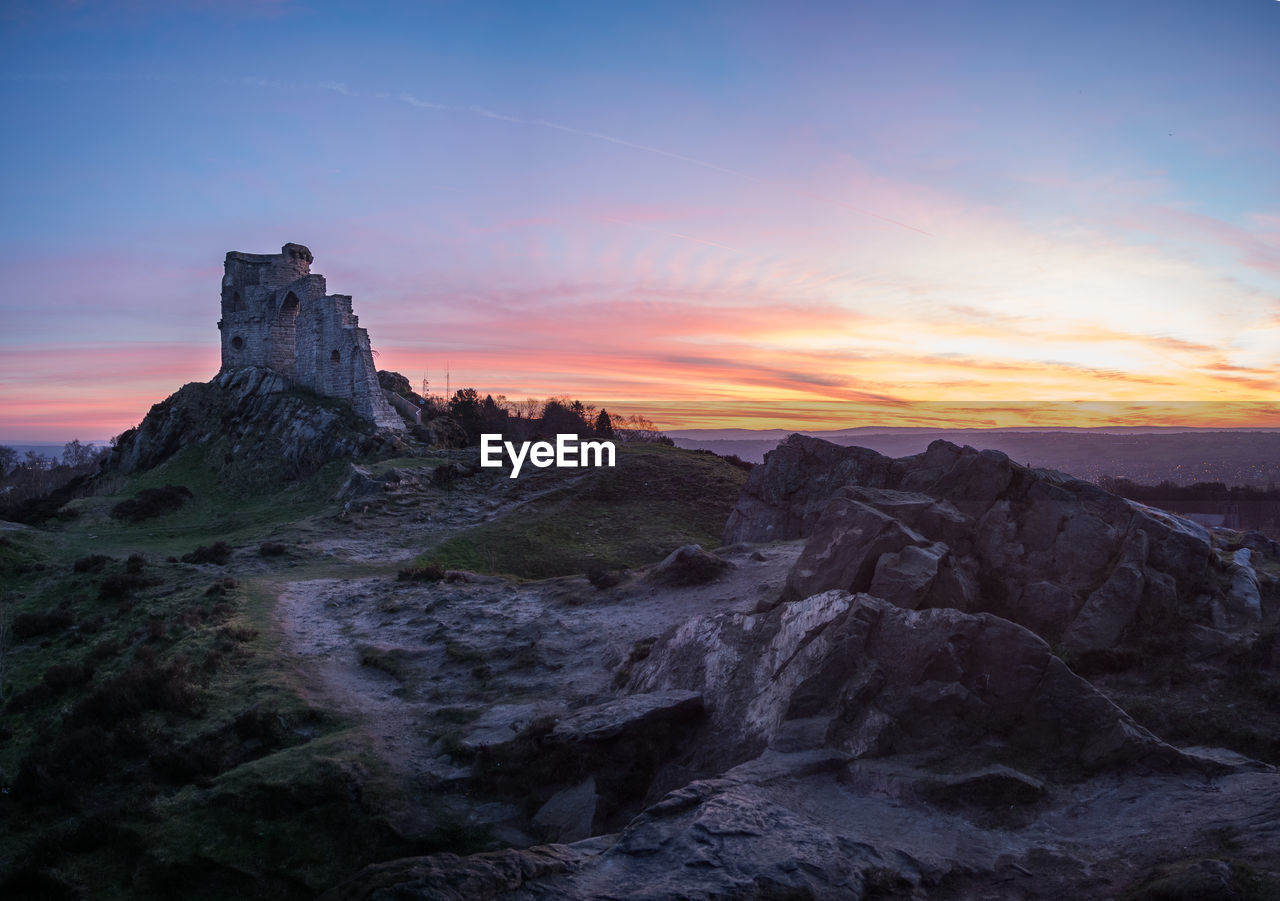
325,436,1280,900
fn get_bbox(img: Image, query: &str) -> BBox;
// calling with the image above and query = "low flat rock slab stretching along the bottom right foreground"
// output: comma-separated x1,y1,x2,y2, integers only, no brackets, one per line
321,754,1280,901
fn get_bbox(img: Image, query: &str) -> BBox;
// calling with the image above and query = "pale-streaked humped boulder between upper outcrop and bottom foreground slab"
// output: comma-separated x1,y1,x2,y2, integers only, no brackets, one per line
631,591,1187,767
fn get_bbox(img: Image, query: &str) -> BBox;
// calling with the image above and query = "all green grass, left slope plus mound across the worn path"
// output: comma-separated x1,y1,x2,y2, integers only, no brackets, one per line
0,447,745,901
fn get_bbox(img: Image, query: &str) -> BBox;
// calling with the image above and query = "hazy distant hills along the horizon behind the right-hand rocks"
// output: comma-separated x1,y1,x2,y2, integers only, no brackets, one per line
667,426,1280,486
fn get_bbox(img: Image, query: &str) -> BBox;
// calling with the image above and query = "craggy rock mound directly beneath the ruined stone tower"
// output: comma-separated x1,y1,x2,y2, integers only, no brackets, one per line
110,367,407,479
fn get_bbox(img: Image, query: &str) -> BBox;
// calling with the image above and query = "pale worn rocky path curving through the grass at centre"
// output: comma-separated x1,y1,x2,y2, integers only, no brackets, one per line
268,465,799,786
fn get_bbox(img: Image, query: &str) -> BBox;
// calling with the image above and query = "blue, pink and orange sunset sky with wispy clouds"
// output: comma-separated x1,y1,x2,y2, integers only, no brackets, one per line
0,0,1280,443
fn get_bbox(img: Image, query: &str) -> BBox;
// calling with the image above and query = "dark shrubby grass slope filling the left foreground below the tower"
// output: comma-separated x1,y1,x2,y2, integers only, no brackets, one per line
0,449,456,898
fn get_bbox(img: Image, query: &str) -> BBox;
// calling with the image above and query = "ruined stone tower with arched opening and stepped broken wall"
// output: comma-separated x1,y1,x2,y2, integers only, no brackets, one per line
218,244,404,429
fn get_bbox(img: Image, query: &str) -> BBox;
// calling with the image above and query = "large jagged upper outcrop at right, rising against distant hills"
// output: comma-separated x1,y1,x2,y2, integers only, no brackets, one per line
724,435,1274,651
